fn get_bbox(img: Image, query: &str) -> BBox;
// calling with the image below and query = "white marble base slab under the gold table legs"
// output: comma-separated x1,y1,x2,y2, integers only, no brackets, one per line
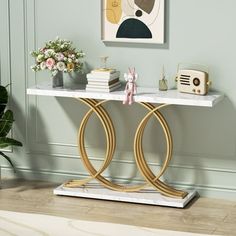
53,184,197,208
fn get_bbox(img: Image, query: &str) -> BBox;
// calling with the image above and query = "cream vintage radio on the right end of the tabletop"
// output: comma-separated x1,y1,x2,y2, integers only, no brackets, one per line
176,69,210,95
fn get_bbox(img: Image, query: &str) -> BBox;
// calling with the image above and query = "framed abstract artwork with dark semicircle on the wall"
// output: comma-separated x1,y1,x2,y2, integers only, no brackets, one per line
102,0,165,44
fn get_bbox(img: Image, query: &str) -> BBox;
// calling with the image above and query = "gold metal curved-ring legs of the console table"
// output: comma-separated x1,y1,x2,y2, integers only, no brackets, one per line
65,98,188,198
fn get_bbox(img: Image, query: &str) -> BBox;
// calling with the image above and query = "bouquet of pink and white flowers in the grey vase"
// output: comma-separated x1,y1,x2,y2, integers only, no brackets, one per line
31,37,85,76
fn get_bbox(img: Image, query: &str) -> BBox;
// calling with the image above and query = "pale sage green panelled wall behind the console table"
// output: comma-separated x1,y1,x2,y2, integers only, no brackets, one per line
0,0,236,199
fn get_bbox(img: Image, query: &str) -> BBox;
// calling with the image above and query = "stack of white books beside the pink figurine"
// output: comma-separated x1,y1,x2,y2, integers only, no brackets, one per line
86,69,121,92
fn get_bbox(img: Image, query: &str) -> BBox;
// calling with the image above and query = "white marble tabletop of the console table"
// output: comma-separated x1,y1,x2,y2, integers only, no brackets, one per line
27,83,224,107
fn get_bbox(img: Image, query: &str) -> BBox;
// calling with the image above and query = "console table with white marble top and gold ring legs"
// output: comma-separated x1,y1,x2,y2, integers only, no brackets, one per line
27,84,224,207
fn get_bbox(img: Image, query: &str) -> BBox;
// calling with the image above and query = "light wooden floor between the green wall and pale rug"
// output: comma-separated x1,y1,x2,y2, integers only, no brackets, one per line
0,179,236,235
